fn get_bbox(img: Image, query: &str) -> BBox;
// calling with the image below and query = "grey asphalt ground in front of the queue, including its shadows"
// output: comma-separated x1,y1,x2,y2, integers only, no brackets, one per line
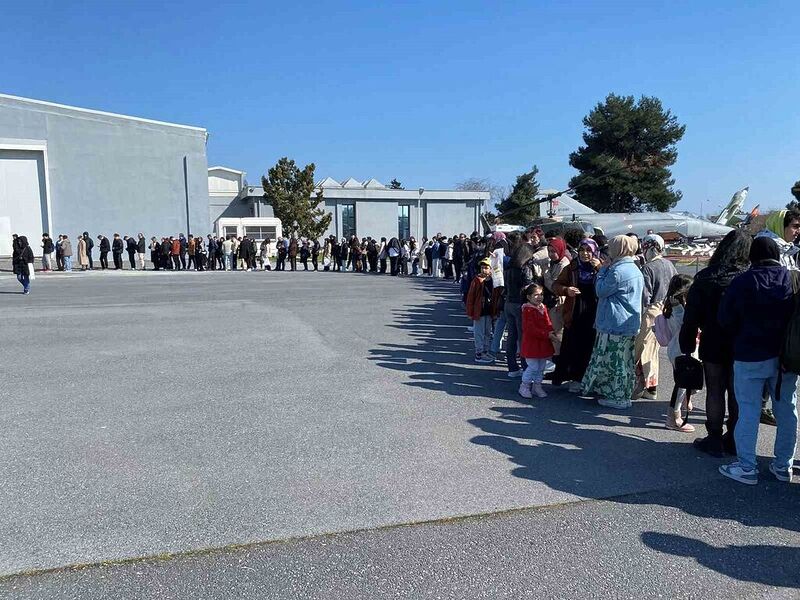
0,272,800,598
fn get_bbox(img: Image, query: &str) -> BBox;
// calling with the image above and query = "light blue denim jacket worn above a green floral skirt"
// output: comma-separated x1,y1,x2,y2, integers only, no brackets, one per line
595,257,644,337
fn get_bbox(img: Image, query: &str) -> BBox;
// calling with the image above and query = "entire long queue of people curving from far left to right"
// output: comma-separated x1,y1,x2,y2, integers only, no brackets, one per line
13,210,800,484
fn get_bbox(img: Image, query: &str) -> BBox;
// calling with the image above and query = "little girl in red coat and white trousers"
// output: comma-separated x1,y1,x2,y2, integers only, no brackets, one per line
519,283,557,398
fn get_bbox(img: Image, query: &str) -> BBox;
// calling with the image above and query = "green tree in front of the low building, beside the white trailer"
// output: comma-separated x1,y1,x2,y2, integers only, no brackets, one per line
261,157,333,239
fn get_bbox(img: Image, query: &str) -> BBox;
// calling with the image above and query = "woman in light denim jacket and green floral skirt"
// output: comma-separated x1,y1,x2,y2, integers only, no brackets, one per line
582,235,644,409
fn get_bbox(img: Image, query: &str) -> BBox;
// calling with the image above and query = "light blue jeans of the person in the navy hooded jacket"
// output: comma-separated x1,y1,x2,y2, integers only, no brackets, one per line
733,358,797,469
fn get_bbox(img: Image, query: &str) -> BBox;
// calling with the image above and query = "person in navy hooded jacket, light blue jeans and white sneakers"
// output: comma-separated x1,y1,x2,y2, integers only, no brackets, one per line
718,237,797,485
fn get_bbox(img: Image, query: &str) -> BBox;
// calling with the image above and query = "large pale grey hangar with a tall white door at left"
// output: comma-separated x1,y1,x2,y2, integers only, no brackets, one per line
0,94,210,255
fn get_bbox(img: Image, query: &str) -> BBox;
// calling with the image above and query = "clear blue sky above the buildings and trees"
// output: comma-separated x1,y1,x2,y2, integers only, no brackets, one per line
0,0,800,212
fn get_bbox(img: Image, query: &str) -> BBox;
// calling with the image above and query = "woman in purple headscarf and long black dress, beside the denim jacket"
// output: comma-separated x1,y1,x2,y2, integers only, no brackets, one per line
553,239,601,394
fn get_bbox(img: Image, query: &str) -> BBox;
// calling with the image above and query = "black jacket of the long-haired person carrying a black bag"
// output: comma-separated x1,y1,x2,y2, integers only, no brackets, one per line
679,267,743,365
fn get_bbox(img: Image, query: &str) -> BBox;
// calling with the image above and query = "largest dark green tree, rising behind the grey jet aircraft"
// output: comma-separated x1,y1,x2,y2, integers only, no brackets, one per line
569,94,686,212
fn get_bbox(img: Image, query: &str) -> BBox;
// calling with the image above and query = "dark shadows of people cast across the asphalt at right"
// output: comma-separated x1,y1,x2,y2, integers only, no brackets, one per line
370,280,800,587
